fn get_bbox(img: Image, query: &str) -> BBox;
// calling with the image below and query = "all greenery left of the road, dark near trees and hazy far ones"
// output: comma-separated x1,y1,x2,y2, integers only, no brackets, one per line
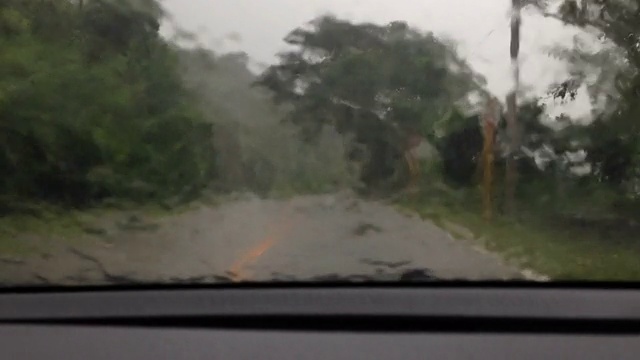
0,0,354,248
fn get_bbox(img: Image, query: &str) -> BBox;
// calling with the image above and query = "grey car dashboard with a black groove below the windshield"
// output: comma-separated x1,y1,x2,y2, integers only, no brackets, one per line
0,286,640,360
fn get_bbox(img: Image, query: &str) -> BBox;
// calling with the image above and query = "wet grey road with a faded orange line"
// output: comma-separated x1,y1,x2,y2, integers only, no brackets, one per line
0,193,523,284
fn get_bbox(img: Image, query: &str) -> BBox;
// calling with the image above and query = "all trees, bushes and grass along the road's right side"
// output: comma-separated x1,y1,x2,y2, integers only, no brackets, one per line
252,6,640,280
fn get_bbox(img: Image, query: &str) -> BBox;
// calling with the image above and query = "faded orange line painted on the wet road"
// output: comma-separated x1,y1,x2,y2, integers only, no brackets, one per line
229,203,295,282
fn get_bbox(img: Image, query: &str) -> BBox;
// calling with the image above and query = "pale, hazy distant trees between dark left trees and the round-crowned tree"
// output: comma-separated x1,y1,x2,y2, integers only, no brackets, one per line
180,49,354,195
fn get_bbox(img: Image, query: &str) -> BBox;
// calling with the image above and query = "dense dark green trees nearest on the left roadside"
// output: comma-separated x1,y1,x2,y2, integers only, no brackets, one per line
0,0,214,205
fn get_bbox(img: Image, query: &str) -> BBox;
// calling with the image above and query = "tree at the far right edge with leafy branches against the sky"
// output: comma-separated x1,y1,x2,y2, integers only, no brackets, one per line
536,0,640,194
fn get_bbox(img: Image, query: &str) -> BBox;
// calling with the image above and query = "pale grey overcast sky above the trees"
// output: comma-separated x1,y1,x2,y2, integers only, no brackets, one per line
163,0,589,121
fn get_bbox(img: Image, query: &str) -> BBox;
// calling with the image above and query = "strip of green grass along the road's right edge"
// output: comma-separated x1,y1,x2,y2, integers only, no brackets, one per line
399,186,640,281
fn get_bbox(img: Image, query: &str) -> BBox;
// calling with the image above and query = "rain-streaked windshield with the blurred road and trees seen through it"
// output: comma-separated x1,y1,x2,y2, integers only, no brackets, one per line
0,0,640,287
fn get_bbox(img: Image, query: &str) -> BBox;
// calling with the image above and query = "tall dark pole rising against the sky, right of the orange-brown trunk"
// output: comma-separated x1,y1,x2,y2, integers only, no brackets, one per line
505,0,522,215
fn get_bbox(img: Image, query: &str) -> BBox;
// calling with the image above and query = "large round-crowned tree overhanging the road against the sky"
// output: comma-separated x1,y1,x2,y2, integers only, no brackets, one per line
257,16,483,185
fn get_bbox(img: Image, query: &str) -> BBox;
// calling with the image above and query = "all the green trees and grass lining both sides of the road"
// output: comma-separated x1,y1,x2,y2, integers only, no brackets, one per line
0,0,640,280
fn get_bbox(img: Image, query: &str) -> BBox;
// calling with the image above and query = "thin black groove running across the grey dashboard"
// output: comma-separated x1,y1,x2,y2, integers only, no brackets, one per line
5,316,640,336
